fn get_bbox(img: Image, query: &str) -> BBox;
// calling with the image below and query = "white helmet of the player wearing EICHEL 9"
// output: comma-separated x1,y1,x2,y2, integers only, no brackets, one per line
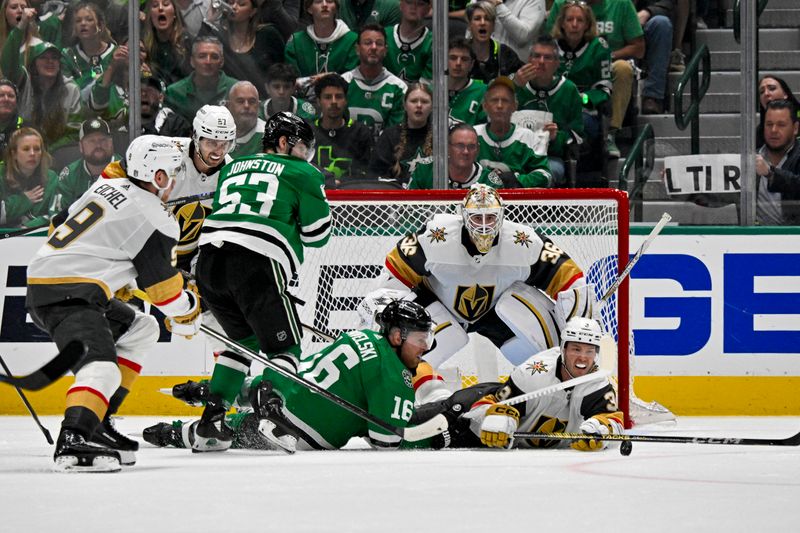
125,135,184,191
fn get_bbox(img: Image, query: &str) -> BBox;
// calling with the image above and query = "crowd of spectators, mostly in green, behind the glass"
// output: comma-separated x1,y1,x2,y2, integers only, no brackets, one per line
0,0,793,224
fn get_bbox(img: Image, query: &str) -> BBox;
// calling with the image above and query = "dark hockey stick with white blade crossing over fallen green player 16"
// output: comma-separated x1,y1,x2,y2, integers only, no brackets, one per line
200,325,447,442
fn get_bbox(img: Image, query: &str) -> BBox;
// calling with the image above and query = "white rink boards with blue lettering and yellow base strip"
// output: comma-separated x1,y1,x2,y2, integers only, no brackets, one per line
0,227,800,415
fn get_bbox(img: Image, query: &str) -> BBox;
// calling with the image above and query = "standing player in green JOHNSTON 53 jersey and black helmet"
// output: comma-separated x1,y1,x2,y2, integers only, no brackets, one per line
194,112,330,451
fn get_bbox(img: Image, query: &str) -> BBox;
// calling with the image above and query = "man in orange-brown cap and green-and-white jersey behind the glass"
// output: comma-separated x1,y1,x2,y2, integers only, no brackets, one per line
475,76,552,188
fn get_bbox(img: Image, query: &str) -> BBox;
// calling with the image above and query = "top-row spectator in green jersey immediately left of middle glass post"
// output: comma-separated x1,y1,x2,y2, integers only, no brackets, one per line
383,0,433,83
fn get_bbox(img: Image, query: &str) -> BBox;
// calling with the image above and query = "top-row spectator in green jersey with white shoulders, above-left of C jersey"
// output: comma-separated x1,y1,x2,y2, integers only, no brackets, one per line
285,0,358,80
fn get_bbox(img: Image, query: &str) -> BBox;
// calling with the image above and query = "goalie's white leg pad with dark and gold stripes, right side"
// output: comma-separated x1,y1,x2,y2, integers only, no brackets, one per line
494,281,559,357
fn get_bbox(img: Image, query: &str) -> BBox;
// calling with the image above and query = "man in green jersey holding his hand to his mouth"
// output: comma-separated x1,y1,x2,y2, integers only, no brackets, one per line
514,36,584,185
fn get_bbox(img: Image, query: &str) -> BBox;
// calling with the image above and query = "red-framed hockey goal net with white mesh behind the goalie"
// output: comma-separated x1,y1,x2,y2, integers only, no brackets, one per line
294,189,674,424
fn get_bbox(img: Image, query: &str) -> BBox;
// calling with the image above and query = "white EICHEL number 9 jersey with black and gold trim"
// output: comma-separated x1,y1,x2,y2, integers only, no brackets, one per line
28,175,183,306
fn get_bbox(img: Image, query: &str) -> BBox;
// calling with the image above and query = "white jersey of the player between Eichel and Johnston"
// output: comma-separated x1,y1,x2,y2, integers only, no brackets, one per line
170,137,233,270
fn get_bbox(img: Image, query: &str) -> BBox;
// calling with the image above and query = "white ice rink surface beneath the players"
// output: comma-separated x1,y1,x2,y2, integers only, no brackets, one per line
0,416,800,533
